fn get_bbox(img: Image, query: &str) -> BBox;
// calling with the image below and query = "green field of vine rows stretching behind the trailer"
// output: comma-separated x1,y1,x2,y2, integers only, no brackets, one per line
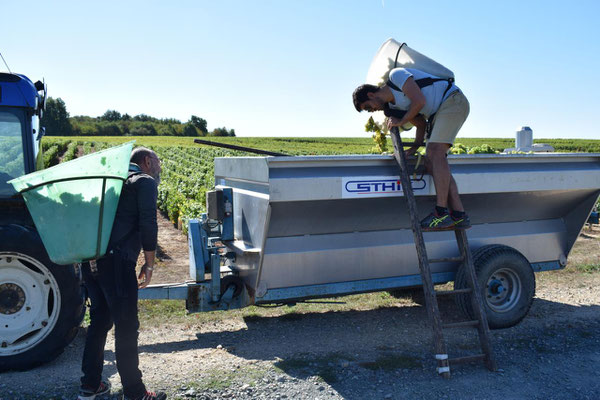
42,137,600,231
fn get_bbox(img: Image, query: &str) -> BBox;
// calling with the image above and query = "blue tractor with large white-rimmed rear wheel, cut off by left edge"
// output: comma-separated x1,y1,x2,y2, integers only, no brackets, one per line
0,73,85,371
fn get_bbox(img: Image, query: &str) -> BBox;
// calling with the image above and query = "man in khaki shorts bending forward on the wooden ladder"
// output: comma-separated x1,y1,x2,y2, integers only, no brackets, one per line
352,68,471,231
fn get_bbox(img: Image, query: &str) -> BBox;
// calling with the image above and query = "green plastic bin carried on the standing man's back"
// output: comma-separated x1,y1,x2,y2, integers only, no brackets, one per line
9,141,134,265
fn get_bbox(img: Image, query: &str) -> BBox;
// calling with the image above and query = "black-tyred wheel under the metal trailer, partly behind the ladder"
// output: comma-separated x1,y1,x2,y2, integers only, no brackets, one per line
454,245,535,329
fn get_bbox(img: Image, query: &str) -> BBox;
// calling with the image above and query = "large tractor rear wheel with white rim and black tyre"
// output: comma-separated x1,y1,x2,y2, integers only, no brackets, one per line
0,225,85,371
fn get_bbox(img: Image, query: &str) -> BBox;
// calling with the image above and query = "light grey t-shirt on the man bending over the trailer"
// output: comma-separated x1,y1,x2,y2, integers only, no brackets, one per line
389,68,458,118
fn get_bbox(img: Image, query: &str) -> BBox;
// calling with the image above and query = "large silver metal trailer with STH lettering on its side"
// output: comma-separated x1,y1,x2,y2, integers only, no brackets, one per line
140,153,600,328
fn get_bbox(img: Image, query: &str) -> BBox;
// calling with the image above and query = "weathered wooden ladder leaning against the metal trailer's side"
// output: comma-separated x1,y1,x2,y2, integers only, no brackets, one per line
391,128,497,378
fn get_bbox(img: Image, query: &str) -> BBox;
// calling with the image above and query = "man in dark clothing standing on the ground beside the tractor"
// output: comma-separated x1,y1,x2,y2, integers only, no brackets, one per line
78,147,166,400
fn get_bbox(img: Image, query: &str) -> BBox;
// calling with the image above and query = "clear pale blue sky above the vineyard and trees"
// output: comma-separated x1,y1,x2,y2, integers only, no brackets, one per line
0,0,600,138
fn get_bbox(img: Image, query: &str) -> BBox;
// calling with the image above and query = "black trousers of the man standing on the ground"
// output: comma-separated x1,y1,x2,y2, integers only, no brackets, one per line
81,253,146,397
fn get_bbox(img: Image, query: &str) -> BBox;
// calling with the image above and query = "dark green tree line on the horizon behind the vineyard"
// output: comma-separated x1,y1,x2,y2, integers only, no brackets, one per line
41,97,235,136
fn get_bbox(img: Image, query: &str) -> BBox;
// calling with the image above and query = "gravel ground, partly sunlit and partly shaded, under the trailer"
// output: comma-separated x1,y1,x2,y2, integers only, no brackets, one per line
0,220,600,400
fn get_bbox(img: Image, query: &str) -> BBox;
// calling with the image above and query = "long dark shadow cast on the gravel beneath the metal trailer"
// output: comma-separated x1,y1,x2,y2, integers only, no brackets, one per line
135,299,600,399
